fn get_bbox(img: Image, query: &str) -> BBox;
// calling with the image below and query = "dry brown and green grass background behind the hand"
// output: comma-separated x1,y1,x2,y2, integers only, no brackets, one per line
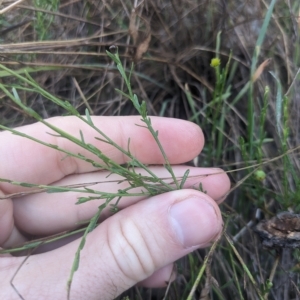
0,0,300,300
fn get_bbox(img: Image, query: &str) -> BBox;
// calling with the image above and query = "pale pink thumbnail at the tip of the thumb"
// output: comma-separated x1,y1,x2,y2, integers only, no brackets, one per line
169,196,222,247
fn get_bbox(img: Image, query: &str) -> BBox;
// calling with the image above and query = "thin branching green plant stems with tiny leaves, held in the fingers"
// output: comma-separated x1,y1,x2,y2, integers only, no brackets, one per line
0,51,189,298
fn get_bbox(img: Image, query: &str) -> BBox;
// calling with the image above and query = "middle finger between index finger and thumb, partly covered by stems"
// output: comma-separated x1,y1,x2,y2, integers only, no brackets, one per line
14,166,230,235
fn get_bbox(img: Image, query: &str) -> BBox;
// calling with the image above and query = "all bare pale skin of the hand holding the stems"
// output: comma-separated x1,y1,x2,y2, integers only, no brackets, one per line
0,116,230,300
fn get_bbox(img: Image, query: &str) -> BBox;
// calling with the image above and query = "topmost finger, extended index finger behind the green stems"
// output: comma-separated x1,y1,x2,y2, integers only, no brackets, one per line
0,116,204,193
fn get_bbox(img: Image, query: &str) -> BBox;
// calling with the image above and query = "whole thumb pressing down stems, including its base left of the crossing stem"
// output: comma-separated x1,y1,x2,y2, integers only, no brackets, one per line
0,190,222,300
